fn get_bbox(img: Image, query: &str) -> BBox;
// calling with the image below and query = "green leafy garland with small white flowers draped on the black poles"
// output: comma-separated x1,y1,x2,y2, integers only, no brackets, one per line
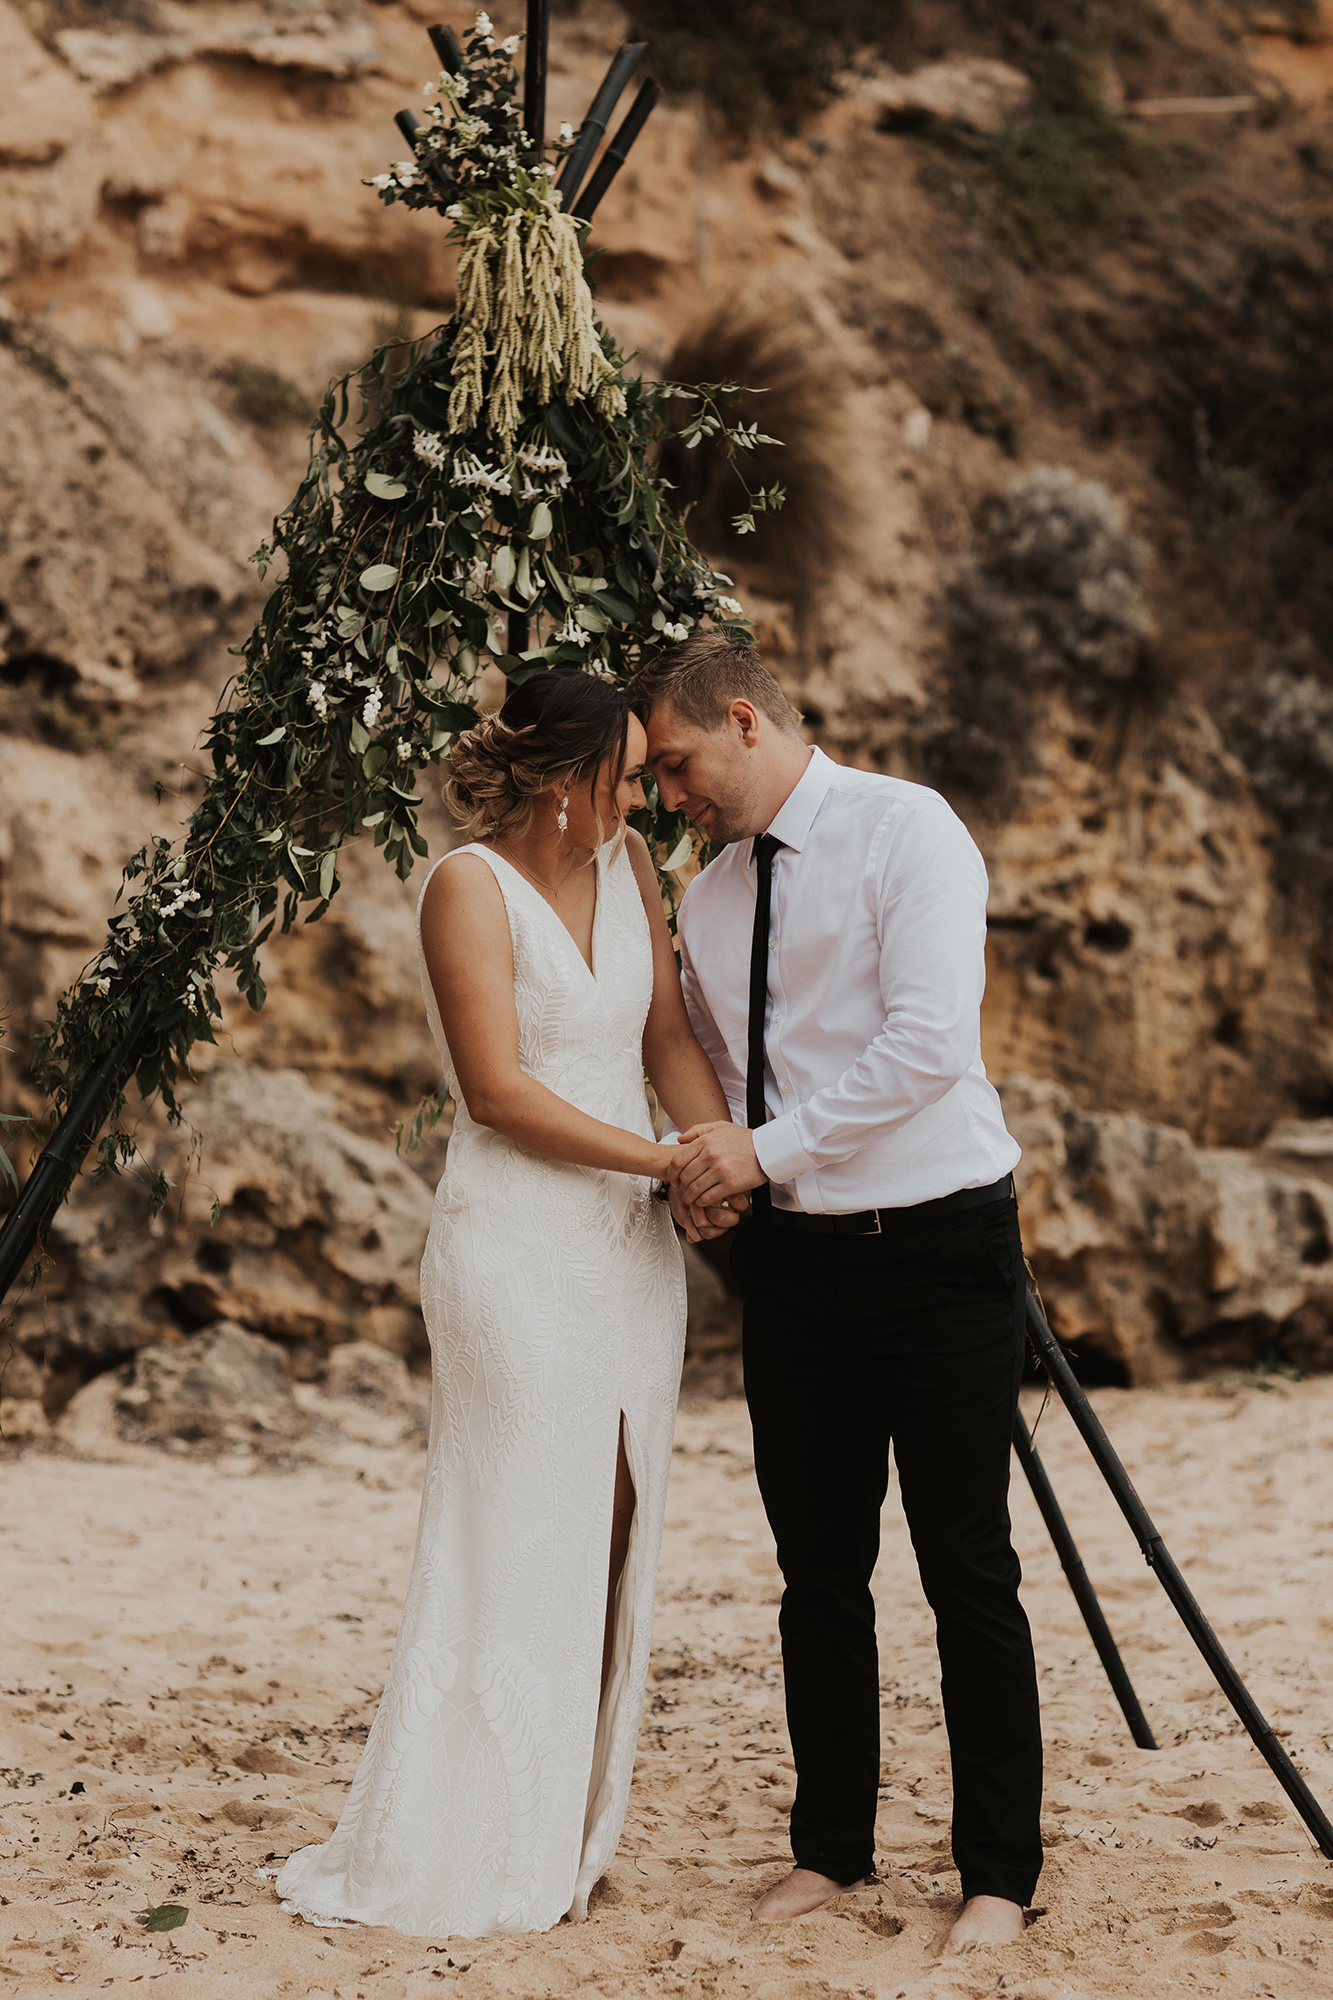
36,11,775,1168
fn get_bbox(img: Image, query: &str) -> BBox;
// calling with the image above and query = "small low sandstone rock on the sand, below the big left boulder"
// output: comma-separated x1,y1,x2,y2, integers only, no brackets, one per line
116,1320,306,1444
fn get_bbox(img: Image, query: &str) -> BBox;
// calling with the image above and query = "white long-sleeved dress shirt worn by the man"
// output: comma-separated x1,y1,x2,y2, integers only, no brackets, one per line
679,750,1019,1214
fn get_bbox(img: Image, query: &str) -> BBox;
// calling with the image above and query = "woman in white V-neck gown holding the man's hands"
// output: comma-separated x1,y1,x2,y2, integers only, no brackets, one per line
276,668,735,1936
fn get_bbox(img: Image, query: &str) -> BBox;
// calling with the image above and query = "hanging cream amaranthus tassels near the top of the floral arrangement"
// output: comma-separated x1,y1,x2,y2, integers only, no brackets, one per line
448,194,624,446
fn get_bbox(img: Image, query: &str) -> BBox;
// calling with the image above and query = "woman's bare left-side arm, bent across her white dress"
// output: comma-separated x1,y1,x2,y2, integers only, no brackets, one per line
420,854,676,1174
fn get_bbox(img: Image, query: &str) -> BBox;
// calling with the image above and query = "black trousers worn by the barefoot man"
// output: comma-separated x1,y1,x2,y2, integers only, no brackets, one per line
733,1198,1041,1904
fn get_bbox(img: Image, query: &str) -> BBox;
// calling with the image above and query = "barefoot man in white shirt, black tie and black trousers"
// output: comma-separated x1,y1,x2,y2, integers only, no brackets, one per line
630,632,1041,1950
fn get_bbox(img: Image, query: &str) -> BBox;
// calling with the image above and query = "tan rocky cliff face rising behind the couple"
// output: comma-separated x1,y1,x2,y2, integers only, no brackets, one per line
0,0,1333,1408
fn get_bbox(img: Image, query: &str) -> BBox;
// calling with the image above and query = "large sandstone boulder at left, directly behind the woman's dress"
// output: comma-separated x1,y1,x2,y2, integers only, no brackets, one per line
18,1062,432,1394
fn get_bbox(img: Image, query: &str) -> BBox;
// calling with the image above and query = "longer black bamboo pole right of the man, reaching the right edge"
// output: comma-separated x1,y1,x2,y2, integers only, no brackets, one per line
1027,1292,1333,1860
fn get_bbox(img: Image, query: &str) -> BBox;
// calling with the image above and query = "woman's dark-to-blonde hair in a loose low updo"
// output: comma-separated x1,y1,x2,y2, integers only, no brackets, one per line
444,666,630,840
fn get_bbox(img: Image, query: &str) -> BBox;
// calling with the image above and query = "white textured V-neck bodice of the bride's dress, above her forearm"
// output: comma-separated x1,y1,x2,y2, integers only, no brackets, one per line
418,842,652,1172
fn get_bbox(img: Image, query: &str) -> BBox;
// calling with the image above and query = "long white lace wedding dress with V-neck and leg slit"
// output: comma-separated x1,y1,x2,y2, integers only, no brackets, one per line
276,846,685,1938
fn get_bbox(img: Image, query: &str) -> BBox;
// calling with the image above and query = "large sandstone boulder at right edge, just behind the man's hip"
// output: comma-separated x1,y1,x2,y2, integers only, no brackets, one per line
1001,1076,1333,1382
